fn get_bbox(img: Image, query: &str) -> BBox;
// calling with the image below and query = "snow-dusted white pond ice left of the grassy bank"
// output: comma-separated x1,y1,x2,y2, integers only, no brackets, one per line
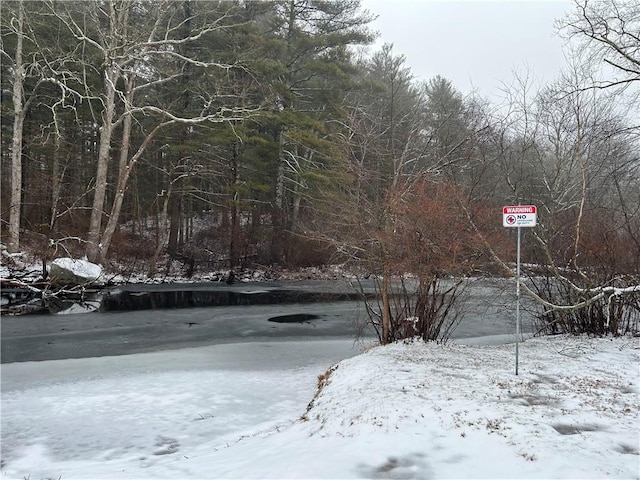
2,340,361,469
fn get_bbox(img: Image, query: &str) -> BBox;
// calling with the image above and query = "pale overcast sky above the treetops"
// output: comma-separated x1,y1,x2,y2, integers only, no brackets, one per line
362,0,573,100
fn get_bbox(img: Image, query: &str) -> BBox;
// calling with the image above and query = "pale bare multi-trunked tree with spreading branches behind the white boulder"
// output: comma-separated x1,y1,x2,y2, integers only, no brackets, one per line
49,0,254,262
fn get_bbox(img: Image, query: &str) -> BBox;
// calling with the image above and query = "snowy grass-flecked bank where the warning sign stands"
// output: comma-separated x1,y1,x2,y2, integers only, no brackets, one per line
292,337,640,478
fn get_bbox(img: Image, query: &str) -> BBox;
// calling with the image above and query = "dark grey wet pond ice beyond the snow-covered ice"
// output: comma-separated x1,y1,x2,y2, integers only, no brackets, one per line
1,279,533,363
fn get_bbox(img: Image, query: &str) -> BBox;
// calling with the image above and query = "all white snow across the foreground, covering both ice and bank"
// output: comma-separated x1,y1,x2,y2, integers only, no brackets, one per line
2,336,640,480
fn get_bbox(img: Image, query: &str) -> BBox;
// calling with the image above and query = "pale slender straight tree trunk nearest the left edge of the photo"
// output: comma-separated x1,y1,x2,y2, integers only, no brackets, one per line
7,1,25,252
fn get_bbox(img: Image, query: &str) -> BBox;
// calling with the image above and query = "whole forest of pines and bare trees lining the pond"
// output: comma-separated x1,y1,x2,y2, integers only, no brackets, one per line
0,0,640,343
